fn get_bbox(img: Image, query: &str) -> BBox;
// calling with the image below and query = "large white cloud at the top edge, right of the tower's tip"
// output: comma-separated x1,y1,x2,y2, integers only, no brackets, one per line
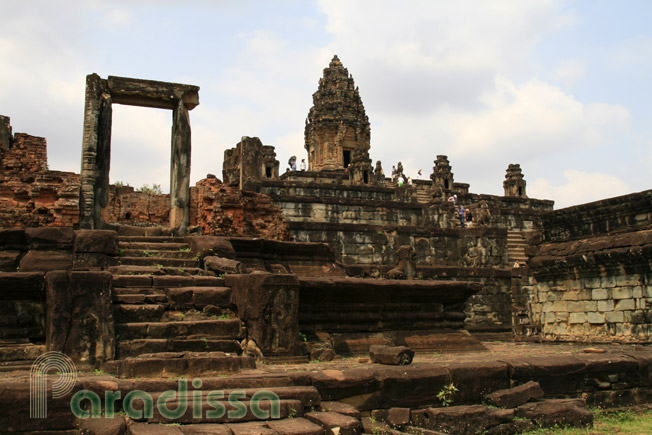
320,0,571,114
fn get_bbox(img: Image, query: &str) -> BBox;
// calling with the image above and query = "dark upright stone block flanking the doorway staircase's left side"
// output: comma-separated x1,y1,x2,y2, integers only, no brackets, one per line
45,270,115,370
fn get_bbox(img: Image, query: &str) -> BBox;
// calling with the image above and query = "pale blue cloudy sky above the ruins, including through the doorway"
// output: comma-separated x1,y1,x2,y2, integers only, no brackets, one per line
0,0,652,208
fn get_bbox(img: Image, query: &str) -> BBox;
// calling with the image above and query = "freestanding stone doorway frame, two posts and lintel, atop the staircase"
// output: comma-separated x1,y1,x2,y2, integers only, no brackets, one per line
79,73,199,235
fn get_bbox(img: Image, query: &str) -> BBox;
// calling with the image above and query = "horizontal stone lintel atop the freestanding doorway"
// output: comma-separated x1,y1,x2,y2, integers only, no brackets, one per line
107,76,199,110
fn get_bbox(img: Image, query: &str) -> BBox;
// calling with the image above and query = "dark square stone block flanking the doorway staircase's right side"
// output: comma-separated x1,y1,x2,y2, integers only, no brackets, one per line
225,273,300,356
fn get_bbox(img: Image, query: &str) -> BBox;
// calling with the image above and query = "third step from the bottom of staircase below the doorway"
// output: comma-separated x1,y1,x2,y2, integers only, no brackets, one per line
115,319,244,340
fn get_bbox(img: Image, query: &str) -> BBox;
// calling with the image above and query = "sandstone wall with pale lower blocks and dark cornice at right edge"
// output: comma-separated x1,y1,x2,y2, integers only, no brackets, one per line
514,191,652,341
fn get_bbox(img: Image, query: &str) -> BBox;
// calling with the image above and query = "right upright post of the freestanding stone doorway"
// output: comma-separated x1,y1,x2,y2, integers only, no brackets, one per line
170,100,190,235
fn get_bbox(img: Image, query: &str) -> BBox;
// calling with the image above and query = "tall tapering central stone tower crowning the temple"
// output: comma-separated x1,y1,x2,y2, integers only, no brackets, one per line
305,55,371,171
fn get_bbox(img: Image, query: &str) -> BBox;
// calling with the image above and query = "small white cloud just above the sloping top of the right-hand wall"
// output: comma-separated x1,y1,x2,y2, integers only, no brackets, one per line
527,169,631,209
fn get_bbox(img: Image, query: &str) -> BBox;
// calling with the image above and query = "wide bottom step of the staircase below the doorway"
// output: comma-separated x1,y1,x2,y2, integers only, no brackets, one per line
104,352,256,378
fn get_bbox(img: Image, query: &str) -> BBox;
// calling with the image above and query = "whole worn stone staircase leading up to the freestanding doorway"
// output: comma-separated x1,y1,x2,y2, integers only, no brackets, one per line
107,236,255,377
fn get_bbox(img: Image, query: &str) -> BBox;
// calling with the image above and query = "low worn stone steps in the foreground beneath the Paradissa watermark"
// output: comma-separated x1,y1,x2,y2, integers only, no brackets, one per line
75,375,361,435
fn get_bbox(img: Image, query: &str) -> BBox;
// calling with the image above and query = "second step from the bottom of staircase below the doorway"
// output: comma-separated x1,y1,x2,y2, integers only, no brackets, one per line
117,337,241,358
